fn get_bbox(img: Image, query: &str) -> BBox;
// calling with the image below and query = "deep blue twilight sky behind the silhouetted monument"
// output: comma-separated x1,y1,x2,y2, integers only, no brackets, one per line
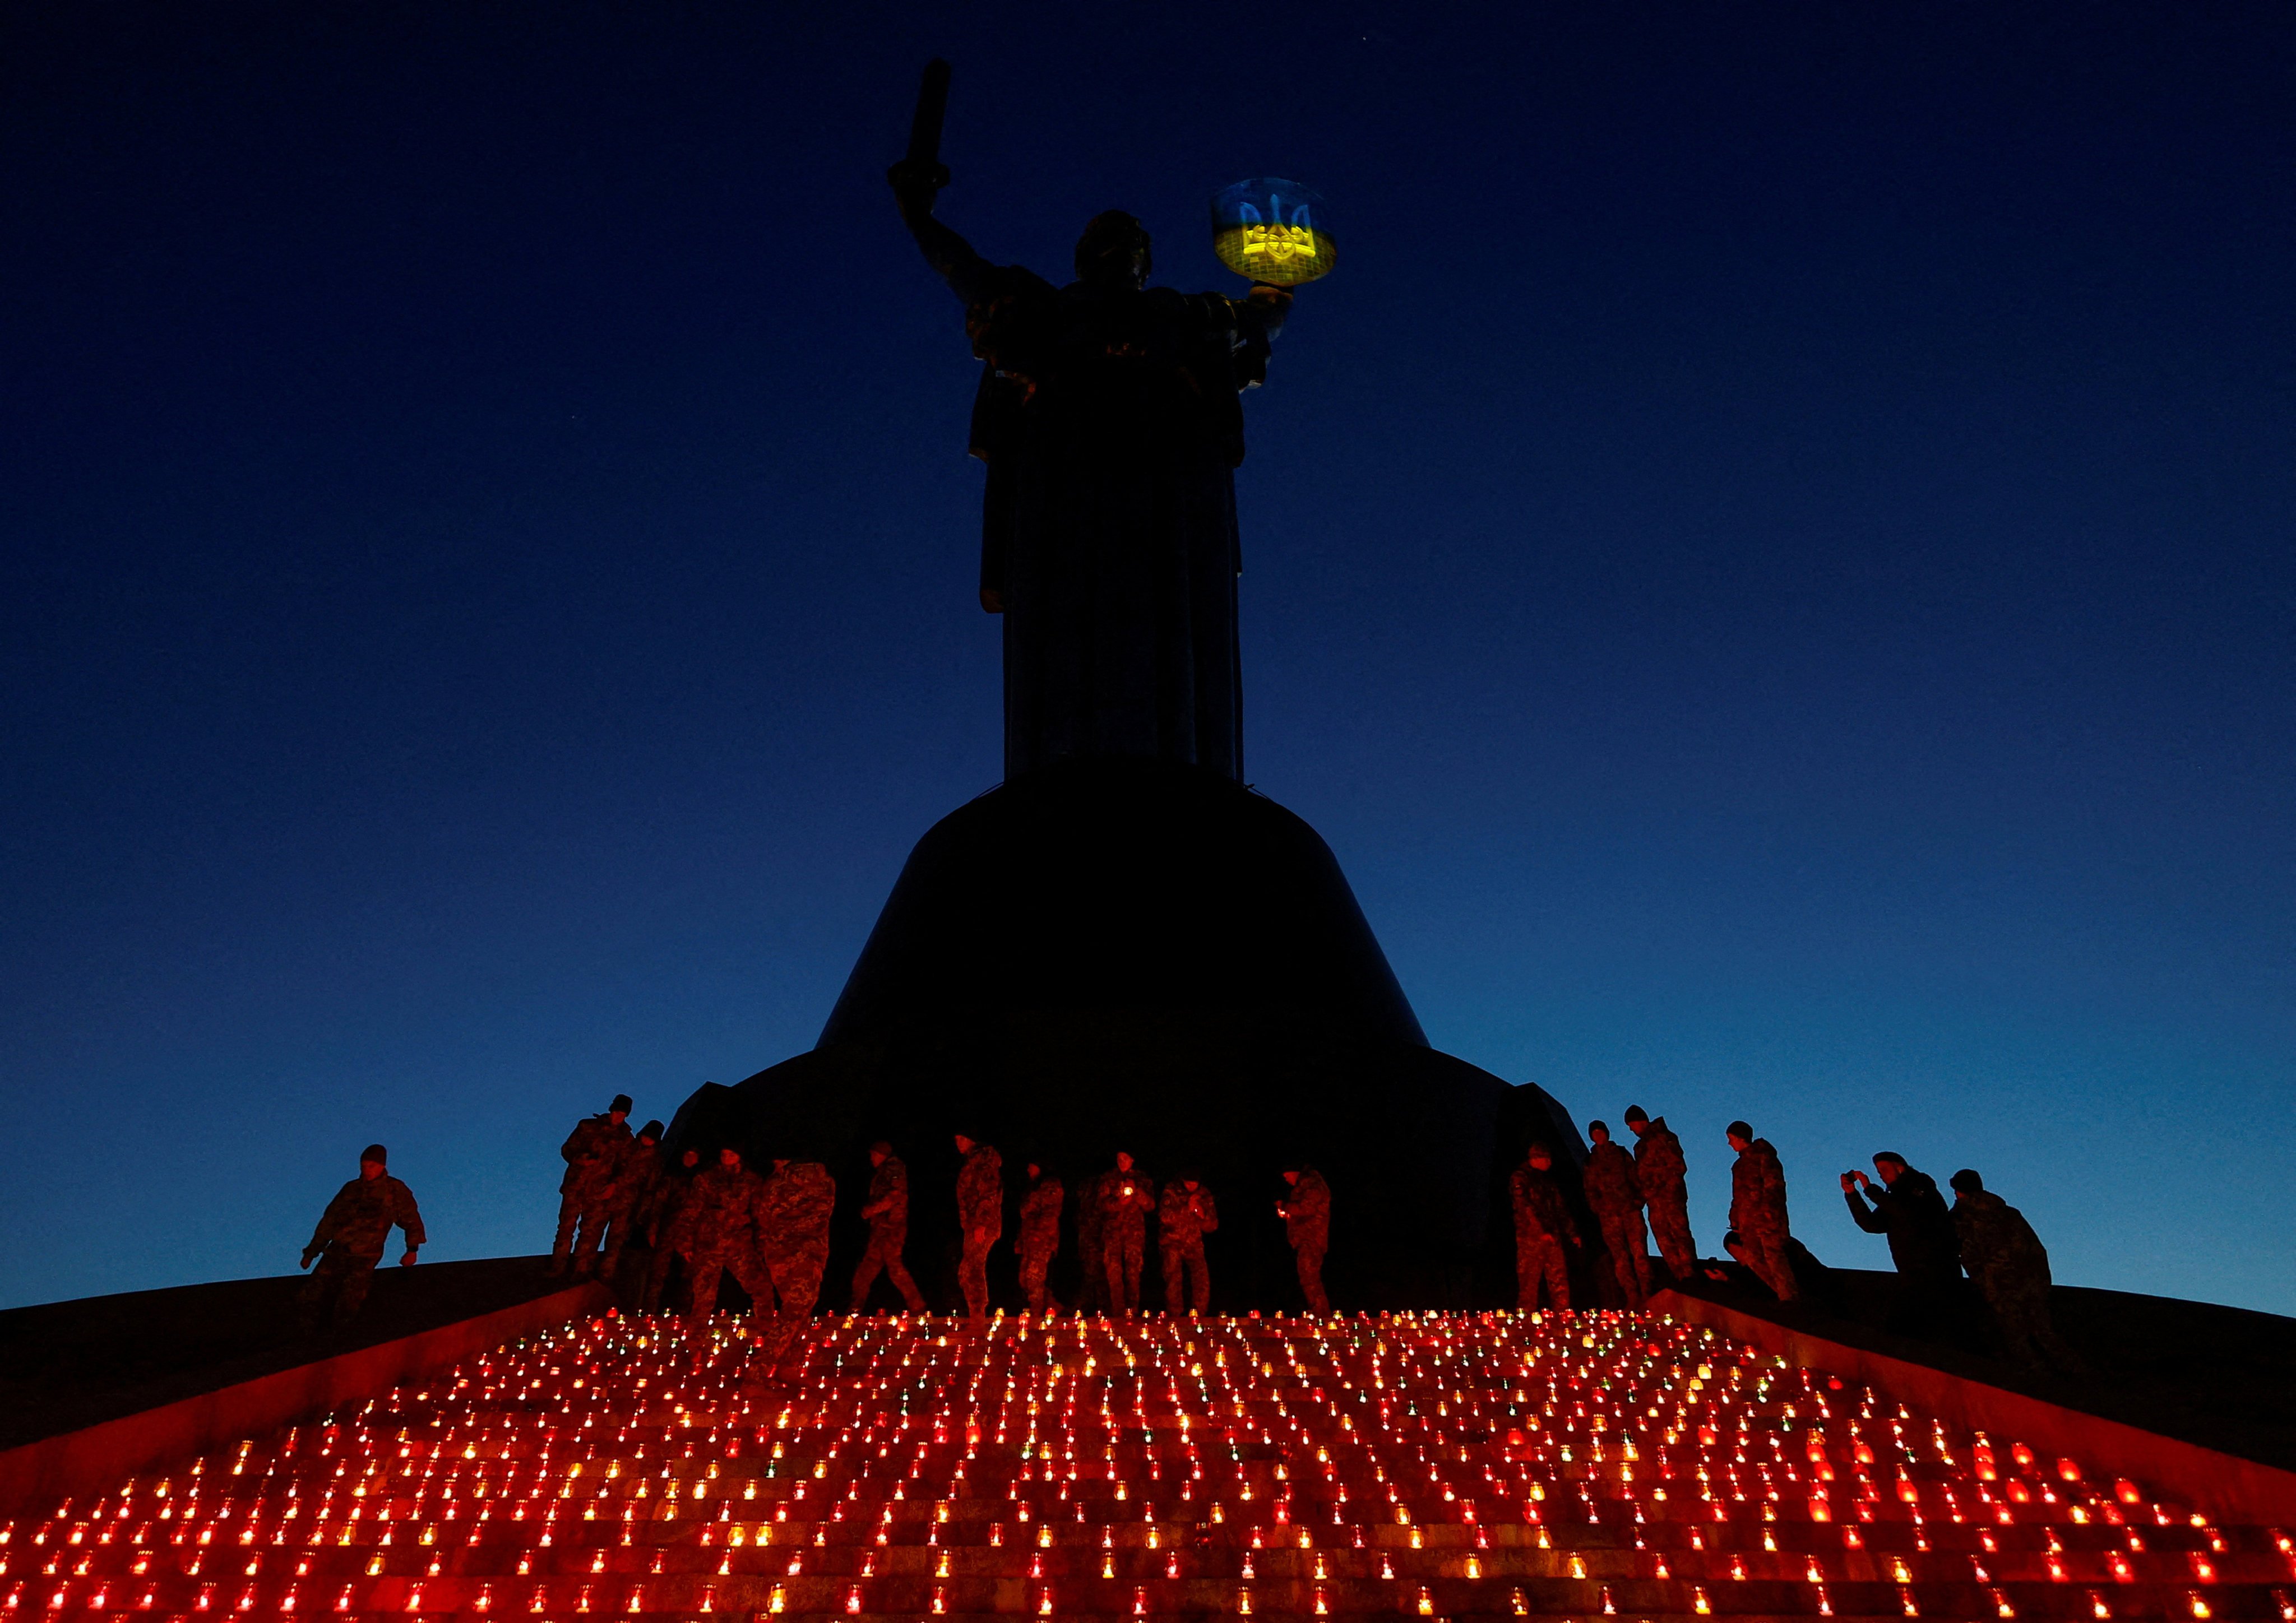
0,0,2296,1311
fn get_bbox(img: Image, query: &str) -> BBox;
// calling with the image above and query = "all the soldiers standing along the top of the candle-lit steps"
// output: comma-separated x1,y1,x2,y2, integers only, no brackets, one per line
298,1093,2080,1370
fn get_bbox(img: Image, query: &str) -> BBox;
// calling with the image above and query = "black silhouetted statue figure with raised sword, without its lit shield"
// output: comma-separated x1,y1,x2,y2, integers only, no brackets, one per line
886,62,1290,781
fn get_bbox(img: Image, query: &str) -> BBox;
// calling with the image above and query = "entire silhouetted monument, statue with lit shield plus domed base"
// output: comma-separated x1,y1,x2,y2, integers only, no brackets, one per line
668,79,1577,1306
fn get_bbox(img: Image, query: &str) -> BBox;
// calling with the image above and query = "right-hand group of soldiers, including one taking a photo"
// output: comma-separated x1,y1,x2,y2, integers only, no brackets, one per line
1508,1104,2082,1373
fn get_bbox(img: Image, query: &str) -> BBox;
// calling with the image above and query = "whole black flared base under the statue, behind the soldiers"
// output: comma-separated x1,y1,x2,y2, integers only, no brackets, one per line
670,762,1577,1311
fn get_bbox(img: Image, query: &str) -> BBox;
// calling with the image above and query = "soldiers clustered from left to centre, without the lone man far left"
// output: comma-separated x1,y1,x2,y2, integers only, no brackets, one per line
551,1095,1332,1352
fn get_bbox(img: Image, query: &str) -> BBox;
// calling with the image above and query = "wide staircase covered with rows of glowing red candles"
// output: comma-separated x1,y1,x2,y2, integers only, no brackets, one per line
0,1313,2296,1623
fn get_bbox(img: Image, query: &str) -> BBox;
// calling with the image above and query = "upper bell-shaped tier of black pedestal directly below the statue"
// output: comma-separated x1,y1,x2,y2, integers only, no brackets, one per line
822,760,1426,1047
